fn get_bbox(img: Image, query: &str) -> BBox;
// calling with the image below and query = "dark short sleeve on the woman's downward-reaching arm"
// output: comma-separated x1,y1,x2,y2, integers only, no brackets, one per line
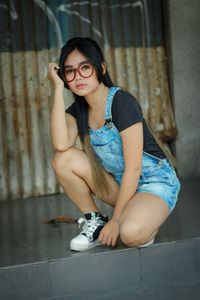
112,90,143,132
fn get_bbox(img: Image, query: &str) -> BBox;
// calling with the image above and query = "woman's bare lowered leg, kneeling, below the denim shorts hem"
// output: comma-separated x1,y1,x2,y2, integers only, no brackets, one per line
119,192,169,247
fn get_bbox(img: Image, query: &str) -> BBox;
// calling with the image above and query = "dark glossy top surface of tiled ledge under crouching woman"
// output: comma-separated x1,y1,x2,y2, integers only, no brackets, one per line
0,178,200,267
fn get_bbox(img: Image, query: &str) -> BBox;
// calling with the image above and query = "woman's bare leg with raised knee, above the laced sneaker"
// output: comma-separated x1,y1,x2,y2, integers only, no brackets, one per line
52,148,119,213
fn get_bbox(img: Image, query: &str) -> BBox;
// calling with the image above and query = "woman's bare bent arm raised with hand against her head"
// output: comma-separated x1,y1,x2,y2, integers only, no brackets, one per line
48,63,78,151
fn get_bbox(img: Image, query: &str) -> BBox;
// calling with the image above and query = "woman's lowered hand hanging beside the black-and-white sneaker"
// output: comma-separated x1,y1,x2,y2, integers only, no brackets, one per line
99,219,119,246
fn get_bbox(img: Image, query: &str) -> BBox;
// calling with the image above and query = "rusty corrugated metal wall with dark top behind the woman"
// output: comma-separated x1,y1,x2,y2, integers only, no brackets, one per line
0,0,176,200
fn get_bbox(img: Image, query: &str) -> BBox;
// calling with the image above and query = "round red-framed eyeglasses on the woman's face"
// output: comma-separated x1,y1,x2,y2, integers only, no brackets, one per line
64,62,94,82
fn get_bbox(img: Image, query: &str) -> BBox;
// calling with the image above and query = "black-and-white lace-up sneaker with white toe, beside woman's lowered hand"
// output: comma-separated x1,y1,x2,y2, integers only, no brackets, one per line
70,212,108,251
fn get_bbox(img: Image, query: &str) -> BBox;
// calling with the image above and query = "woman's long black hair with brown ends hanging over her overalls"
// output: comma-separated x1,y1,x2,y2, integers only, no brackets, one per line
59,37,113,198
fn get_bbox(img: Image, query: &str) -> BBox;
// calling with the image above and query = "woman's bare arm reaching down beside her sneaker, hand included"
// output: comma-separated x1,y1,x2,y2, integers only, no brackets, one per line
99,122,143,246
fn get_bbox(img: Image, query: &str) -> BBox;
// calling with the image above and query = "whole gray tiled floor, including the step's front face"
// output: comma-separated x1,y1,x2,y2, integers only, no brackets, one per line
0,178,200,300
